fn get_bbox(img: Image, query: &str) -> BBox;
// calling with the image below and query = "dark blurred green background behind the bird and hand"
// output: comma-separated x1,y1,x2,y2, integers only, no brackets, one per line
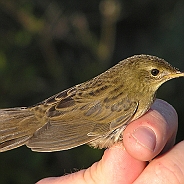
0,0,184,184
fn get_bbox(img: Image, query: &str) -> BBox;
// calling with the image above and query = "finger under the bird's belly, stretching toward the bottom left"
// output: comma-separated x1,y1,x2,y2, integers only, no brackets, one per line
37,143,146,184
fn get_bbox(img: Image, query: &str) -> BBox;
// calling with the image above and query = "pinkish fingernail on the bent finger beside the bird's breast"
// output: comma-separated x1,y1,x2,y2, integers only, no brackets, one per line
132,126,156,151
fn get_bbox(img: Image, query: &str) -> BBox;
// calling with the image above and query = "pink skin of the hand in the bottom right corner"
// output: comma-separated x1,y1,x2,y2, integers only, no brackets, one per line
134,141,184,184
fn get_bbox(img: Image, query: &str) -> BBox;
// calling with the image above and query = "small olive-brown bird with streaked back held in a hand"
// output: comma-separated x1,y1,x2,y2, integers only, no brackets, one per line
0,55,184,152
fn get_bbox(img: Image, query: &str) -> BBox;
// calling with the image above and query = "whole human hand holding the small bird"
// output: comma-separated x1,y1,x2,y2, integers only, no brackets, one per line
37,99,184,184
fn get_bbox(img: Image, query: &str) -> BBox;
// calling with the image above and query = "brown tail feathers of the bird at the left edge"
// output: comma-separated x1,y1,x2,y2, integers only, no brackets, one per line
0,107,39,152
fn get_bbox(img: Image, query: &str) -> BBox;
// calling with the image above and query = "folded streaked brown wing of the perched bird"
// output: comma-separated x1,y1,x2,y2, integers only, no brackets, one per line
26,84,138,152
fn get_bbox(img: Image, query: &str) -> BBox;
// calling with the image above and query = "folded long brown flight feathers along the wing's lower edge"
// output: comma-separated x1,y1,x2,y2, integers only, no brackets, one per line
26,121,98,152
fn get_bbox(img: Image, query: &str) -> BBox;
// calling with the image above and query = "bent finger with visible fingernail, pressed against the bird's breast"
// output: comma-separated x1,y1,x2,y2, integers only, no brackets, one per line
123,99,178,161
